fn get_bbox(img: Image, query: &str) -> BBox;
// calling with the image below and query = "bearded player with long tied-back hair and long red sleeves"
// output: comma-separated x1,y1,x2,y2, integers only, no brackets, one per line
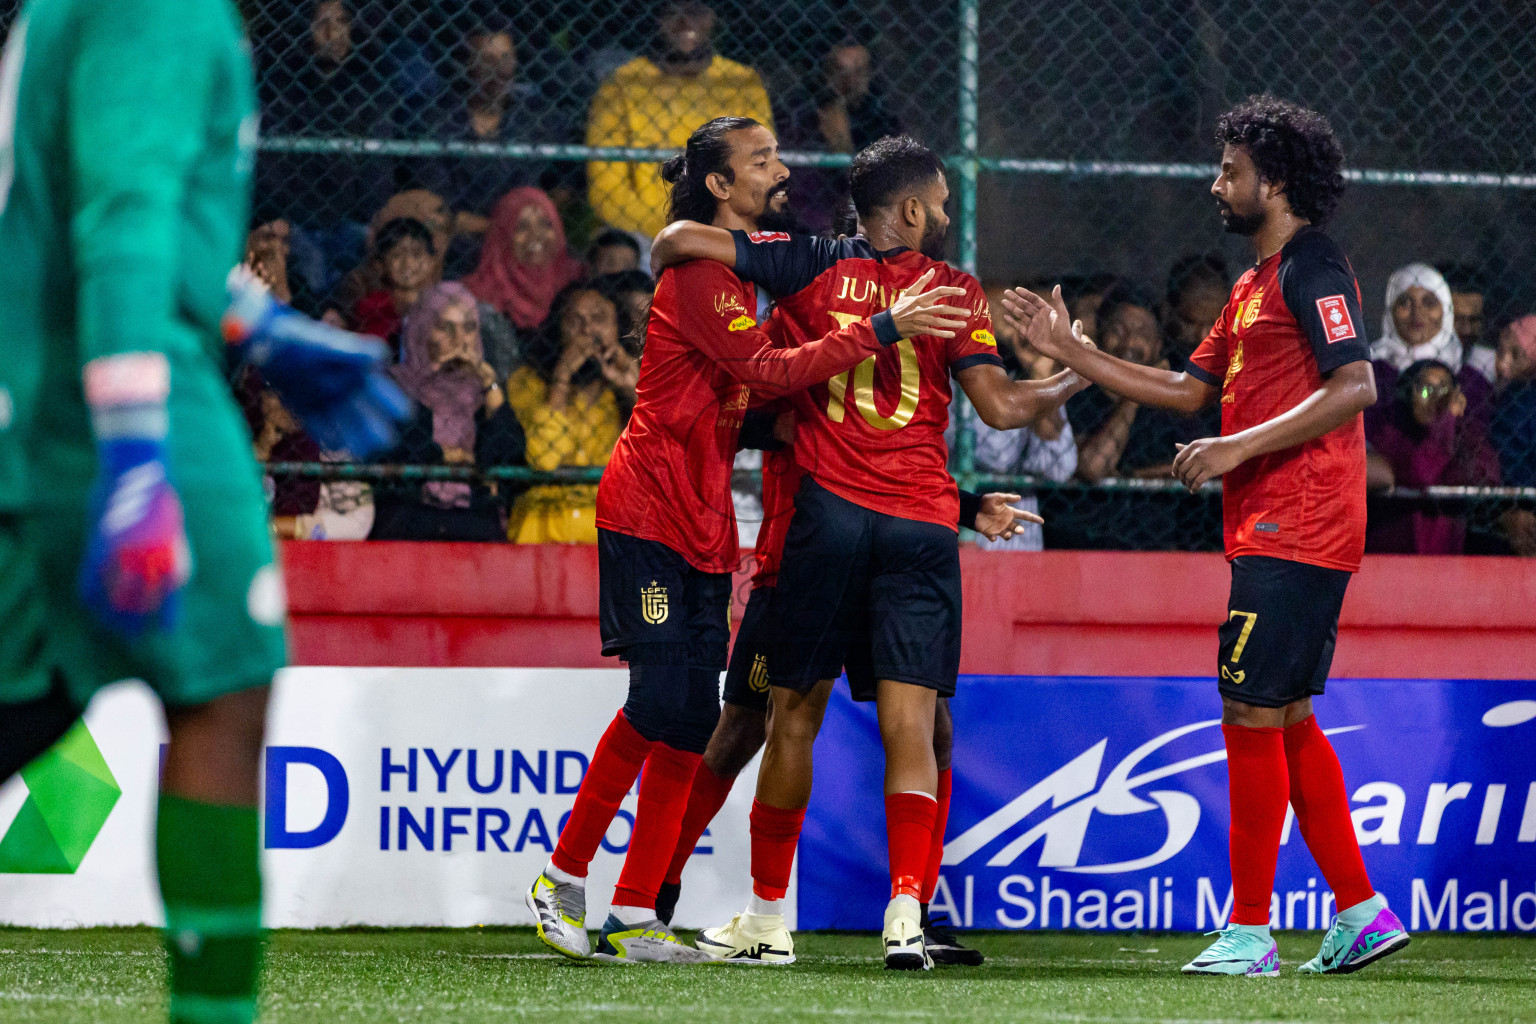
527,118,965,963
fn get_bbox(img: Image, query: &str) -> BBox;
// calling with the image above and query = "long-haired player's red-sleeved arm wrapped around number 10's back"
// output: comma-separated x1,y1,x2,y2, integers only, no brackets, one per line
673,261,966,398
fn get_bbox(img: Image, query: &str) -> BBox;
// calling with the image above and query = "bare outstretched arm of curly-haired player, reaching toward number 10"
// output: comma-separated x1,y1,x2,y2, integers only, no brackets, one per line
1003,286,1218,413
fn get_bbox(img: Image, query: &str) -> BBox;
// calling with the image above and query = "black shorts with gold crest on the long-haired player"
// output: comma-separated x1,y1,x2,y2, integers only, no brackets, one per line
598,530,731,668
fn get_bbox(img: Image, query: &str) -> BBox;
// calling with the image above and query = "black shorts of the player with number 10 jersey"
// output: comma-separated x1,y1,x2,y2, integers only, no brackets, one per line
768,477,960,700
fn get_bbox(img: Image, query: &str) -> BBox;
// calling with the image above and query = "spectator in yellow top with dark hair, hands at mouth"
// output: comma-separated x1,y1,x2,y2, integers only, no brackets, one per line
507,282,641,543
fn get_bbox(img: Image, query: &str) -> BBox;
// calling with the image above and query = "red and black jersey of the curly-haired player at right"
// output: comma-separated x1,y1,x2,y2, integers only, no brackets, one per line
1187,227,1370,573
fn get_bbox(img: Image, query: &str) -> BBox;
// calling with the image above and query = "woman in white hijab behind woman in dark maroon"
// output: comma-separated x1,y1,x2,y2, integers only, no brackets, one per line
1366,263,1493,430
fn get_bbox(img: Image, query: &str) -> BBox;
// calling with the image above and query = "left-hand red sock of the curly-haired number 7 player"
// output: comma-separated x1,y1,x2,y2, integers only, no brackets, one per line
1221,725,1290,924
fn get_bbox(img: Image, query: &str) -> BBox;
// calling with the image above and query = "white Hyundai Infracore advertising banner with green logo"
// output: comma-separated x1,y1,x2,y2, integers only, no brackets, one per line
0,668,796,929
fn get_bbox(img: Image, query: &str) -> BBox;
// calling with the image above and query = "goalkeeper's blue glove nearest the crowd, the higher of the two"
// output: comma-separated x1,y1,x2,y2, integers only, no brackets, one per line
223,267,412,459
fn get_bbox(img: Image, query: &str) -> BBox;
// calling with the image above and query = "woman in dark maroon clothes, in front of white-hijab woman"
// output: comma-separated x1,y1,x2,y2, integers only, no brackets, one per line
1366,359,1499,554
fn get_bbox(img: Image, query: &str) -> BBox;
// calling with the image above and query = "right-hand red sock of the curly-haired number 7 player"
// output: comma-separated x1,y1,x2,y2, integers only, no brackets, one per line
1286,715,1376,910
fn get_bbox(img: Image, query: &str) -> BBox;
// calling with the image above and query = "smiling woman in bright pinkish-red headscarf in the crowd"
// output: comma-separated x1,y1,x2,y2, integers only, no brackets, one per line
464,187,582,330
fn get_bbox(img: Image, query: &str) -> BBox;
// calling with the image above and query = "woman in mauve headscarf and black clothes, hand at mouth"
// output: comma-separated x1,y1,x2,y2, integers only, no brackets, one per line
369,282,524,540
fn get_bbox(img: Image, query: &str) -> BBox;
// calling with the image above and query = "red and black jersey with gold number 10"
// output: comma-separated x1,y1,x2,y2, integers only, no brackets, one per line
733,232,1003,530
